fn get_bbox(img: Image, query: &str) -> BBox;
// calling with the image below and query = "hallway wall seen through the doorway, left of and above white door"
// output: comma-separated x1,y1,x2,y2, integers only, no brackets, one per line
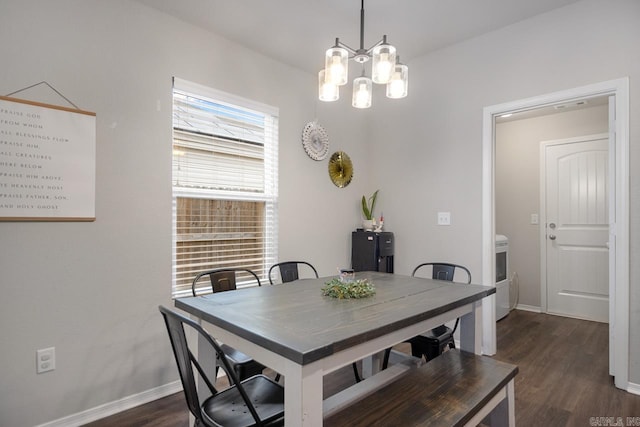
495,105,609,307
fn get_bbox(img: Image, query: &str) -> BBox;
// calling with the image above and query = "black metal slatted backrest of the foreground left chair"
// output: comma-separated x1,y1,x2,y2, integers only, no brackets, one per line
158,306,260,425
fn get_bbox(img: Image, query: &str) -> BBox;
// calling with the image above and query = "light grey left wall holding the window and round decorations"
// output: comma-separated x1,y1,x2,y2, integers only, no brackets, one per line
0,0,370,427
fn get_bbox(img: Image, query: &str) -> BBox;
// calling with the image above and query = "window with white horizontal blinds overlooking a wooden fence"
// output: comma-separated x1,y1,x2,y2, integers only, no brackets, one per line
172,78,278,298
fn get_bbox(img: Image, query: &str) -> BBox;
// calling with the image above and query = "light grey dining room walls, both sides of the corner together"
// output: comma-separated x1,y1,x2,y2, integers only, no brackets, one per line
0,0,640,427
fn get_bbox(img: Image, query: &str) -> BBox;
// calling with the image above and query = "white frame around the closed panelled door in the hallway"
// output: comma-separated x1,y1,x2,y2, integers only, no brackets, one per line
538,133,615,320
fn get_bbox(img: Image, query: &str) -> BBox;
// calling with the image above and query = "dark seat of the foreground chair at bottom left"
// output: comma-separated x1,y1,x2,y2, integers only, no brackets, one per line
202,375,284,427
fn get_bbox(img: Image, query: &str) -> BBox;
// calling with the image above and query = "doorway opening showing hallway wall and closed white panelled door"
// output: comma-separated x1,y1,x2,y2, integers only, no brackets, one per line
494,108,609,322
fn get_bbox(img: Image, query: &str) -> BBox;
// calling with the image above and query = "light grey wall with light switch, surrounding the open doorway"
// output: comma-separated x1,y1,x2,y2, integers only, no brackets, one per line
370,0,640,384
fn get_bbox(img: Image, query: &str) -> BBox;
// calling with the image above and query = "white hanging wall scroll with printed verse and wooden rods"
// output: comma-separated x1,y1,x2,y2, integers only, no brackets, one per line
0,96,96,221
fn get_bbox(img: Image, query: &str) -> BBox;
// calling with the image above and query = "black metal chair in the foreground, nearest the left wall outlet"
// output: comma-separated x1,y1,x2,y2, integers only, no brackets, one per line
159,306,284,427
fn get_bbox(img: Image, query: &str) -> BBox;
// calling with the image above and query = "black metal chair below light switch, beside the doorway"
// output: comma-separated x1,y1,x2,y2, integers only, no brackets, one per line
382,262,471,369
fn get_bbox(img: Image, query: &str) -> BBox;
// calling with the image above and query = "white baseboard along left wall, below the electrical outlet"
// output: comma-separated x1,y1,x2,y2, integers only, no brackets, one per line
36,381,182,427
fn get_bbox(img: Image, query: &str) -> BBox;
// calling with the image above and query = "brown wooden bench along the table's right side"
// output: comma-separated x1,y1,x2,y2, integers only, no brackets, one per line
324,349,518,427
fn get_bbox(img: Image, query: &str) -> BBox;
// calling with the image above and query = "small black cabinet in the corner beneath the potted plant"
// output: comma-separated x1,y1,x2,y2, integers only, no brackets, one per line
351,231,395,273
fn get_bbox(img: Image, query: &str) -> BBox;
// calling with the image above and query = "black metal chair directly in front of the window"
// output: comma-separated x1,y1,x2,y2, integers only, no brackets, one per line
191,268,268,381
